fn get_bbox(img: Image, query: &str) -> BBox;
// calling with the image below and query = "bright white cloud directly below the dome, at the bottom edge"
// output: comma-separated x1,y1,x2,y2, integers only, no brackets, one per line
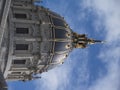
34,51,89,90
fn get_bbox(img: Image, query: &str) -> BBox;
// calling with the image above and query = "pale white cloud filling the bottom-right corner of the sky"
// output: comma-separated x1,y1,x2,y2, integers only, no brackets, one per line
89,48,120,90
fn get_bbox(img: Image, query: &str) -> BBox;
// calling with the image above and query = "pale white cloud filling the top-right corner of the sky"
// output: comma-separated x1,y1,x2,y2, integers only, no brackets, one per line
95,0,120,41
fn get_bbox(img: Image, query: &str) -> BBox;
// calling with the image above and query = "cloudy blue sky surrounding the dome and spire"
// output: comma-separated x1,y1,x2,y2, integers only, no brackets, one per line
8,0,120,90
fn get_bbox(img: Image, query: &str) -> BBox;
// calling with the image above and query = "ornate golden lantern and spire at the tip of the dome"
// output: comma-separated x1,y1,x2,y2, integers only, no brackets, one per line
72,32,104,48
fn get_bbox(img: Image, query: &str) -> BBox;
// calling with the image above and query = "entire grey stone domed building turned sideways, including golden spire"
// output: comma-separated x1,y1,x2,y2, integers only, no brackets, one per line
0,0,101,88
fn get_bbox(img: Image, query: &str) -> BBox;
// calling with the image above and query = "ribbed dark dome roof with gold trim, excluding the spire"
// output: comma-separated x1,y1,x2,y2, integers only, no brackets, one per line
40,8,72,70
